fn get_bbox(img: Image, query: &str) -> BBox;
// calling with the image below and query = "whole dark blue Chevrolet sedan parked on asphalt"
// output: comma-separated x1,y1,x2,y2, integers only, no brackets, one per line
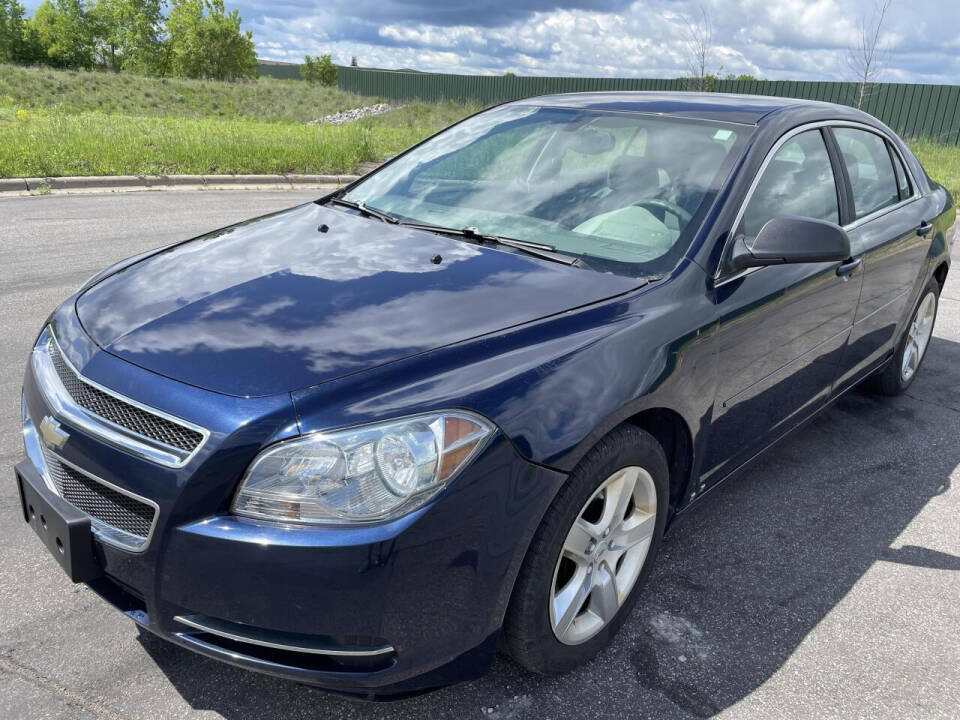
16,93,956,698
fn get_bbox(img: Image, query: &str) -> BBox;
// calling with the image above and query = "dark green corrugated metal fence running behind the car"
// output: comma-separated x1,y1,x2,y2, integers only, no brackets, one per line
339,67,960,145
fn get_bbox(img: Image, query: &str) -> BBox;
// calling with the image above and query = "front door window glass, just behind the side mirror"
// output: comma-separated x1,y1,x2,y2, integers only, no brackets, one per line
743,130,840,237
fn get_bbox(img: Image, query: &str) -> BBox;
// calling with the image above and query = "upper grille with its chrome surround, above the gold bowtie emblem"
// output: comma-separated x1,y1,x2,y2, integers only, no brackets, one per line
33,327,210,468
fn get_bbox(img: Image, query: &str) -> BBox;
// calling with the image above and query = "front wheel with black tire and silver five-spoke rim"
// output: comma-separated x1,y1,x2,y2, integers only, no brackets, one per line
504,426,669,674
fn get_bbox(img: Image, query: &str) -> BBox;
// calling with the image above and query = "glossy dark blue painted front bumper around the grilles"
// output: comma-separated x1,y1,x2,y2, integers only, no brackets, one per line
17,312,565,697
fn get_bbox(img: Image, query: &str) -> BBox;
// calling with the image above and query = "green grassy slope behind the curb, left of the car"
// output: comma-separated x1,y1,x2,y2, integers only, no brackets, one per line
0,65,477,177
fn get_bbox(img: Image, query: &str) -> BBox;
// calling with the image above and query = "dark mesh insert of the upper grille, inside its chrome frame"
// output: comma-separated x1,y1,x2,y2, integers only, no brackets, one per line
47,339,203,453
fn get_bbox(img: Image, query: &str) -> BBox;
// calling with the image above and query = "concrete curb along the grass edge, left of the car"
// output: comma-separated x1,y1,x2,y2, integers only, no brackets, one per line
0,175,360,196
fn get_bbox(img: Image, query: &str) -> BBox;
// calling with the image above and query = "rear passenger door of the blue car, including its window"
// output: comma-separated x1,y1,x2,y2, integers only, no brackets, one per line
831,126,932,391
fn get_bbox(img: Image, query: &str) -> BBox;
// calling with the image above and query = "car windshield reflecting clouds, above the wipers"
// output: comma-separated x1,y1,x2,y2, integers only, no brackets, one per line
344,105,747,276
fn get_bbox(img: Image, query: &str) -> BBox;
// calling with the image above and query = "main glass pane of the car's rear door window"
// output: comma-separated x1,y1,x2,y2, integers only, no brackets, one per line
833,127,909,220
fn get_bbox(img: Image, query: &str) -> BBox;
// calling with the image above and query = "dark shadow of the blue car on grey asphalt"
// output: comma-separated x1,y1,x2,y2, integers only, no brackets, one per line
135,338,960,720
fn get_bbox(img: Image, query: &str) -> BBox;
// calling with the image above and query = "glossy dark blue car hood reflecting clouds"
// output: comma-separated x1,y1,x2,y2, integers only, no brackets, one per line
76,203,642,396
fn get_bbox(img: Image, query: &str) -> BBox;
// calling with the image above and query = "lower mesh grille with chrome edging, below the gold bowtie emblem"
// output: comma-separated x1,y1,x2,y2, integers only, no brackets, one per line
43,449,156,549
